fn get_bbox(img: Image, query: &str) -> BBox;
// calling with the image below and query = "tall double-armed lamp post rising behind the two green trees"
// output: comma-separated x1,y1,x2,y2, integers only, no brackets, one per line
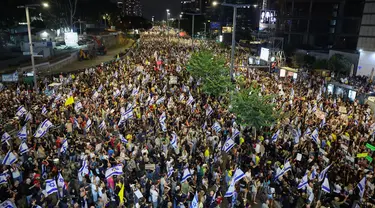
212,1,258,81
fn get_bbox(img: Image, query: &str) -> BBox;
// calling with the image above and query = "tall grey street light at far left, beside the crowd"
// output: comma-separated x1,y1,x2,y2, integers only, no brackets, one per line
17,3,49,92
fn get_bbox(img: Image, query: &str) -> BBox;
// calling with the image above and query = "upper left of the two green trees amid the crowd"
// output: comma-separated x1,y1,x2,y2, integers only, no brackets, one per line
187,50,233,97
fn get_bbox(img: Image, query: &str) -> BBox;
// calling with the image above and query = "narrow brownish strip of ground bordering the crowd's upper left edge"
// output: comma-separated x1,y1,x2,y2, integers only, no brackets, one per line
44,40,134,75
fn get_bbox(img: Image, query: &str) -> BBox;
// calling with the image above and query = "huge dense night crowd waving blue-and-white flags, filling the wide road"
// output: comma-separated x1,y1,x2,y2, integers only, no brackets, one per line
0,30,375,208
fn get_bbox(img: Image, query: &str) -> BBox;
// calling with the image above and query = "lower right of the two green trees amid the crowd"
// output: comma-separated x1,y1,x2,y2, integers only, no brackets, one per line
231,88,278,129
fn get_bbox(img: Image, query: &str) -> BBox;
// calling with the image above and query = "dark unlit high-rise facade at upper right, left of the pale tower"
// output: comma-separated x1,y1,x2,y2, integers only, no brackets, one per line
278,0,364,50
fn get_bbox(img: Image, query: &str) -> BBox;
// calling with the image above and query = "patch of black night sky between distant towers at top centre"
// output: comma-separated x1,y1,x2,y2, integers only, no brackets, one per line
141,0,181,21
